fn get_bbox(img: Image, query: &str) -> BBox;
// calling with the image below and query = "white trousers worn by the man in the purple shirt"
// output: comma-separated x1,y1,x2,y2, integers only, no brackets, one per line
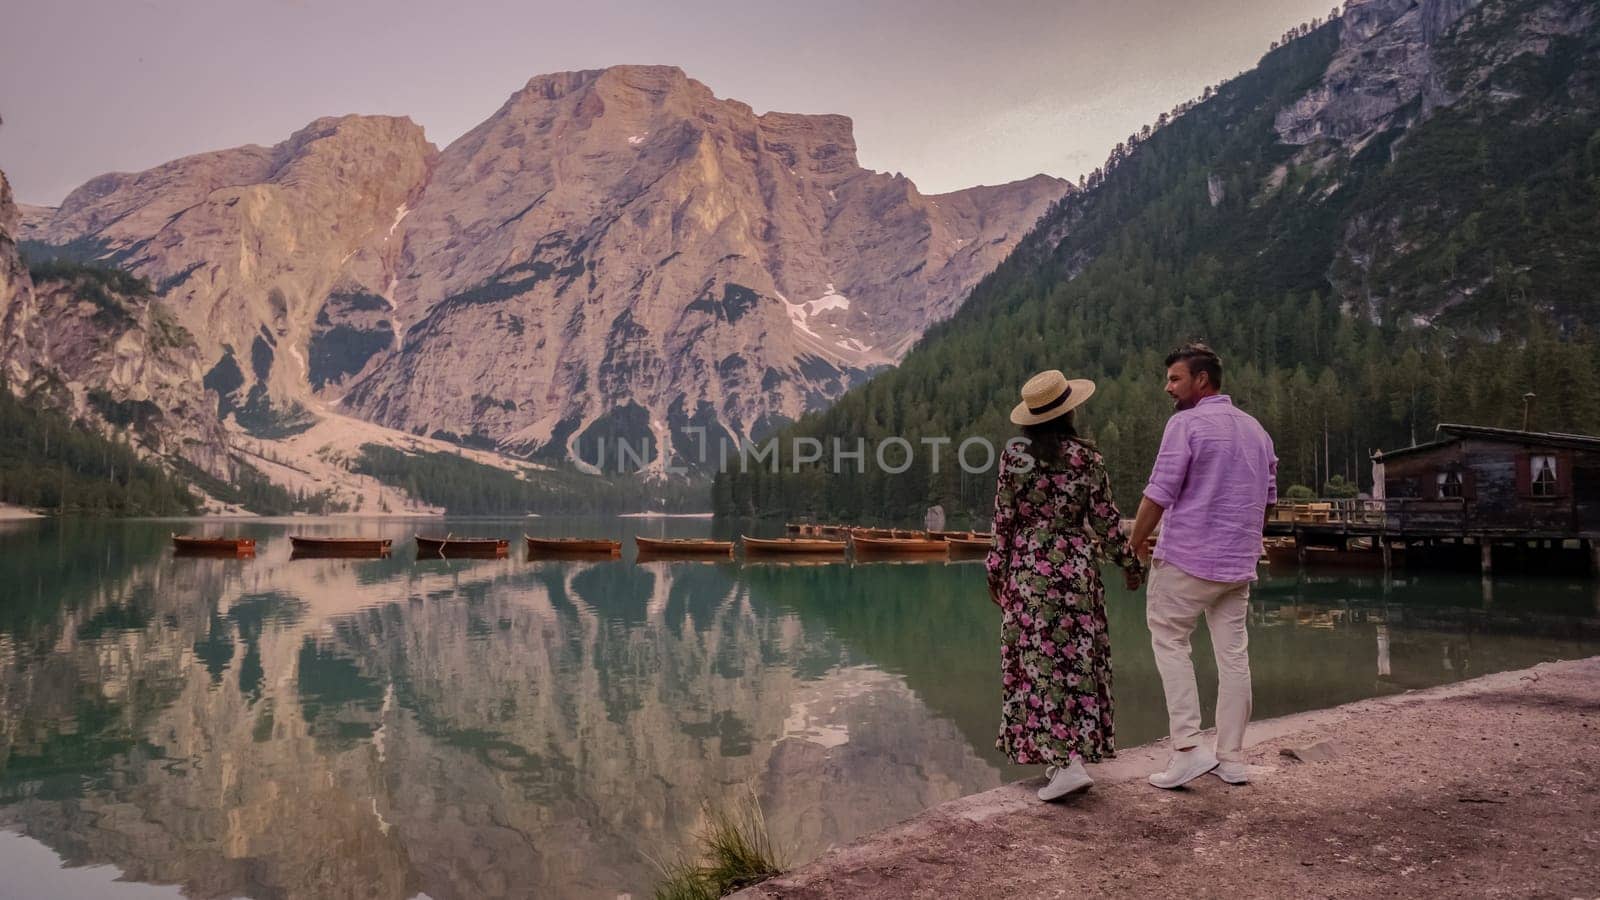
1146,560,1250,762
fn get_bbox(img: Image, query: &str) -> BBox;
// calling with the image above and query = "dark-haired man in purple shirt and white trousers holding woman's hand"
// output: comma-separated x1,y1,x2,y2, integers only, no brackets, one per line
1133,344,1278,788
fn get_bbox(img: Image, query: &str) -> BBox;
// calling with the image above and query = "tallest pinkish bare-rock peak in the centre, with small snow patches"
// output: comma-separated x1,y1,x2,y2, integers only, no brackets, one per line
346,67,1064,470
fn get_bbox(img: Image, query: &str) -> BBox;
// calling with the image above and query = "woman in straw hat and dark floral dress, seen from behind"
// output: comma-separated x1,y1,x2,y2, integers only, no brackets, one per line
987,370,1144,801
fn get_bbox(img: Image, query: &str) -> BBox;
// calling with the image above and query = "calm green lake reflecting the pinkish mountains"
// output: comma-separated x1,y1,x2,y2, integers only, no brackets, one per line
0,519,1600,900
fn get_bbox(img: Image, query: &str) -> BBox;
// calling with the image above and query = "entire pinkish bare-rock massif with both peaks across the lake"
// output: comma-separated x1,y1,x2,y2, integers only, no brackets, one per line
22,66,1067,490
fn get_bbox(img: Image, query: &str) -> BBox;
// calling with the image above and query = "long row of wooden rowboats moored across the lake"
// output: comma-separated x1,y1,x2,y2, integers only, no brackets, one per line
173,525,994,559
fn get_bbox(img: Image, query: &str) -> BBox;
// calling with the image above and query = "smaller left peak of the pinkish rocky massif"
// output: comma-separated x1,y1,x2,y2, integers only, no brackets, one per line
24,115,437,437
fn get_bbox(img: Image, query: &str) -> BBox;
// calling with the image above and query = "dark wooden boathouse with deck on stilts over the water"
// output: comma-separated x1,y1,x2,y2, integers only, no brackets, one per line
1266,424,1600,575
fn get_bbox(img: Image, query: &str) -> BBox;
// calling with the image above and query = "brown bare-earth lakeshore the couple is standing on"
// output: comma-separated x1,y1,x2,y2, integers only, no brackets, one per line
739,657,1600,898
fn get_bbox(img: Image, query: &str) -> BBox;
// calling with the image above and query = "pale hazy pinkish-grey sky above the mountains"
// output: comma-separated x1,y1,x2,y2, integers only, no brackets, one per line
0,0,1334,205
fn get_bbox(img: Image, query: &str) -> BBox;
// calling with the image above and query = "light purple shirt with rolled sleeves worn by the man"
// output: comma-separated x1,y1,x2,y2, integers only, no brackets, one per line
1144,394,1278,581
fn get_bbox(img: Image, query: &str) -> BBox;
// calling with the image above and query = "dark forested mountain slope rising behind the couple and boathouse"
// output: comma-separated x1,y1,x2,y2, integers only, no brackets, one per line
715,0,1600,519
